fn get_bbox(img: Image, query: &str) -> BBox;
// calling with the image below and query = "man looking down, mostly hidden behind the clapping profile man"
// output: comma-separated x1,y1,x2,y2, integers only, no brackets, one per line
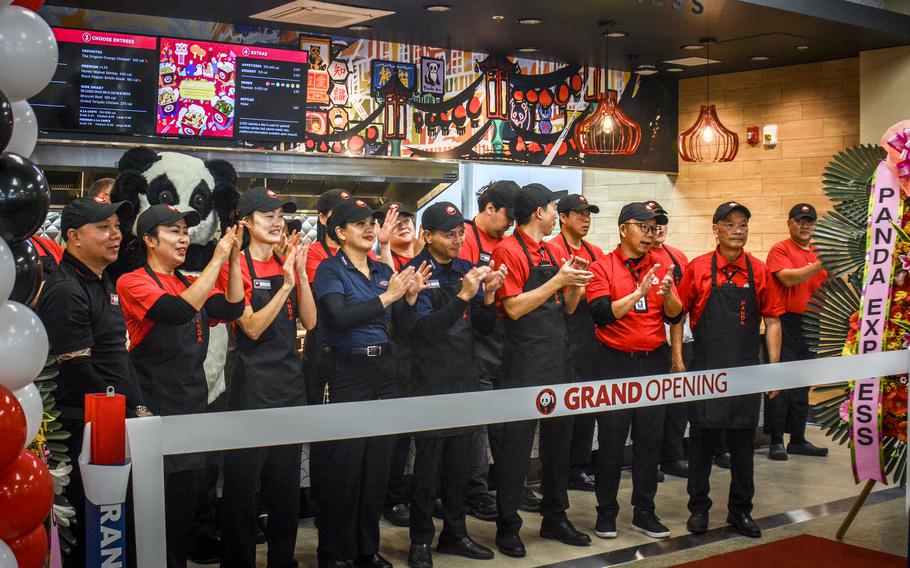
458,180,524,521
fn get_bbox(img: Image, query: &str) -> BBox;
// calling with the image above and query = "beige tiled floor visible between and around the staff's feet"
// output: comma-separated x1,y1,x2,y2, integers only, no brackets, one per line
230,429,907,568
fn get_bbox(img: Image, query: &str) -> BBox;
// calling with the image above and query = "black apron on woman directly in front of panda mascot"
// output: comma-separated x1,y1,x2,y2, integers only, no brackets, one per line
130,264,209,472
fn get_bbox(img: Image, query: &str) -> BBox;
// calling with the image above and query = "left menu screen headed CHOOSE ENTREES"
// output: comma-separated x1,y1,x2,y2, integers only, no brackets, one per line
29,28,157,135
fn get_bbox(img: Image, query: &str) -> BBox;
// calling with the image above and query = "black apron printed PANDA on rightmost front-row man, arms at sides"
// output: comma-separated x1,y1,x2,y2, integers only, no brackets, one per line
689,252,762,428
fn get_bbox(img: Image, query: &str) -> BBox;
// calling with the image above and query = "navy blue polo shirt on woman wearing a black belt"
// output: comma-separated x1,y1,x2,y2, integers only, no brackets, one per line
313,250,392,349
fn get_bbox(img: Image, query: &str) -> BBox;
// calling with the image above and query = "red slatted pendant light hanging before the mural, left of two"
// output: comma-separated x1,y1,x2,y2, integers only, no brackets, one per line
575,25,641,156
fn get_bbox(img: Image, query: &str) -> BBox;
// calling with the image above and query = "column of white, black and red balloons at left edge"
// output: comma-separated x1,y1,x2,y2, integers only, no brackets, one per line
0,0,57,568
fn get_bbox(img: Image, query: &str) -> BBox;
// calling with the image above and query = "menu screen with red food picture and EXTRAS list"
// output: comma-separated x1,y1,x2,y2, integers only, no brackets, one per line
155,38,308,140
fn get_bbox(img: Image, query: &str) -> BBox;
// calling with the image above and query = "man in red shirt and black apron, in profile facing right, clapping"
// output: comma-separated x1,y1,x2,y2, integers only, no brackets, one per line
490,183,591,558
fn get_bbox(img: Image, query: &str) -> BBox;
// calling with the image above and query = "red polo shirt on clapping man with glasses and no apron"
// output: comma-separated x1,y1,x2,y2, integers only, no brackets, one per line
587,246,667,352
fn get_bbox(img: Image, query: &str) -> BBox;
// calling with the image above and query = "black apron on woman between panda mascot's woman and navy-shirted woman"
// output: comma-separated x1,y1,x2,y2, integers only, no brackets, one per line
228,249,306,410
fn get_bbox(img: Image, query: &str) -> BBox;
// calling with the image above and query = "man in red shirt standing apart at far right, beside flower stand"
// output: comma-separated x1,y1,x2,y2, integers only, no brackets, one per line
765,203,828,460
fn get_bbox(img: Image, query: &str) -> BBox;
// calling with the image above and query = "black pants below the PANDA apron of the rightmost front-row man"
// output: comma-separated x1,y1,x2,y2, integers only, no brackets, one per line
688,424,755,513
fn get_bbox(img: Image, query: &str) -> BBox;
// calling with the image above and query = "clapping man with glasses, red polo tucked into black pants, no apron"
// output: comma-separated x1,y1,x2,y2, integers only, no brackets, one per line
587,203,682,538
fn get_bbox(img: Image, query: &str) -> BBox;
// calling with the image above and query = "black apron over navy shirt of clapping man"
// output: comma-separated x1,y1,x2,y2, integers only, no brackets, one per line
413,272,480,437
